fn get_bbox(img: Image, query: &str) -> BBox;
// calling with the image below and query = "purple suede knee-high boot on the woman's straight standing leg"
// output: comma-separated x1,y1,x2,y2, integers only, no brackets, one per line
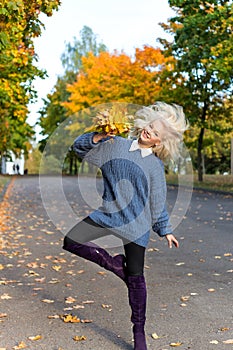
127,276,147,350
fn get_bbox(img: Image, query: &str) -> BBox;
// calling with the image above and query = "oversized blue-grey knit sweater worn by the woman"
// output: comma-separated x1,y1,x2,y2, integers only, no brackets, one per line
74,133,172,247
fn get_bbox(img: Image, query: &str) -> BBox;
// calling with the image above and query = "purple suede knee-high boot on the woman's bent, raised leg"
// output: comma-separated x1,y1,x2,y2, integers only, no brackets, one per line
63,236,126,282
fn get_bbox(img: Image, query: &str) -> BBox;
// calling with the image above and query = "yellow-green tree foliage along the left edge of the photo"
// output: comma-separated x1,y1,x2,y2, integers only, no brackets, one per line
0,0,60,169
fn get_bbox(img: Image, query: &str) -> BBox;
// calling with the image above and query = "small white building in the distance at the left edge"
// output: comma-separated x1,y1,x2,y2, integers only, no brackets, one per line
2,151,24,175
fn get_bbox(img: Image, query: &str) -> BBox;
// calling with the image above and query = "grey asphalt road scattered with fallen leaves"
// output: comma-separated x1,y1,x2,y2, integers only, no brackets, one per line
0,176,233,350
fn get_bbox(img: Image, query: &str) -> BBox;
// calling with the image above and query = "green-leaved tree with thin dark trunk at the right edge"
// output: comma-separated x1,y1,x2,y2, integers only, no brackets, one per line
161,0,233,181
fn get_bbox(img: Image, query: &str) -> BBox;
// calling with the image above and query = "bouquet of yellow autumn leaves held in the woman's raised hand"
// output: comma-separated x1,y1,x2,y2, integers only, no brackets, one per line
89,106,133,135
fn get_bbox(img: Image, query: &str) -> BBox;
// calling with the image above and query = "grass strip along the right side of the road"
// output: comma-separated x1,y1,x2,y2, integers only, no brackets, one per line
166,174,233,193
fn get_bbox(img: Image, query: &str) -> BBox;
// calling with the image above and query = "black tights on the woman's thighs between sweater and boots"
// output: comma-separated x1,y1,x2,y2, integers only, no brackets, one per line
64,217,145,276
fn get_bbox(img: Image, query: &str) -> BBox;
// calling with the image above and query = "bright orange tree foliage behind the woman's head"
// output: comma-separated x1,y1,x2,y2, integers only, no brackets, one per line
62,46,167,114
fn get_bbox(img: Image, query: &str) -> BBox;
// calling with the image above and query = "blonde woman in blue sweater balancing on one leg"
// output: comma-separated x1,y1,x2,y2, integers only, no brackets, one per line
63,102,187,350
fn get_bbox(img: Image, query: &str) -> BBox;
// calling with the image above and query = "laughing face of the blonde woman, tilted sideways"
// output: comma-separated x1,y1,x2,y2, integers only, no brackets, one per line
138,120,163,148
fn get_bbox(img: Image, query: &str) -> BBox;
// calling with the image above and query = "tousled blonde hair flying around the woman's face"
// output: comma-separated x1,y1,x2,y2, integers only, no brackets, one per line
130,102,189,161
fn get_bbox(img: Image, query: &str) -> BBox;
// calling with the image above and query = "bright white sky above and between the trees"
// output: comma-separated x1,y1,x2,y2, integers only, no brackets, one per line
28,0,173,137
